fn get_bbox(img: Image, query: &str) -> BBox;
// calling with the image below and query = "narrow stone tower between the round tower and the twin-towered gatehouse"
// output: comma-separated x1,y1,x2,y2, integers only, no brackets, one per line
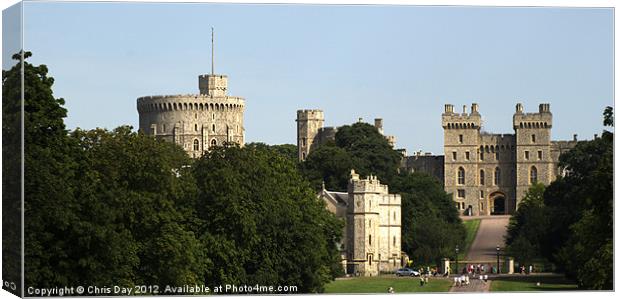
295,109,325,161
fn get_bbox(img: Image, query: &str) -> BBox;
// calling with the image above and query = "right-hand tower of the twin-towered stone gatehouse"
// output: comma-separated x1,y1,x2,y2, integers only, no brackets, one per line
512,103,556,205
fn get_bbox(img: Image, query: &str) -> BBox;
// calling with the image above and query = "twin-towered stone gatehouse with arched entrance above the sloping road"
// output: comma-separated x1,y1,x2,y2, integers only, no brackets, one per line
435,104,575,215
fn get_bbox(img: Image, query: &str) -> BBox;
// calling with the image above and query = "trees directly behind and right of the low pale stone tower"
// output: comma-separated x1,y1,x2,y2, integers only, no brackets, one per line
300,123,465,263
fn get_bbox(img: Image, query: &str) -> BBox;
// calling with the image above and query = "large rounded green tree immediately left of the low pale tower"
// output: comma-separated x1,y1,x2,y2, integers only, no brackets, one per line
193,145,342,292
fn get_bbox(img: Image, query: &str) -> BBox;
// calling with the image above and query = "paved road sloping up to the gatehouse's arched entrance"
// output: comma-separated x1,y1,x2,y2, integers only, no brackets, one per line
463,216,510,262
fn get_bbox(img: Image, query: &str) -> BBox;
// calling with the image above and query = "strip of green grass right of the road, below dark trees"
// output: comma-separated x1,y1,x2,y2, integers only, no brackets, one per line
490,276,577,292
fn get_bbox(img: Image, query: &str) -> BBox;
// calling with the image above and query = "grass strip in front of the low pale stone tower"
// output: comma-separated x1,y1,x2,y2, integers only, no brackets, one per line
325,276,452,294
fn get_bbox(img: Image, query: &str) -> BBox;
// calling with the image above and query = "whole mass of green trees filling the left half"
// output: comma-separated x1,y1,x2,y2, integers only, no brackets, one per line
15,54,343,292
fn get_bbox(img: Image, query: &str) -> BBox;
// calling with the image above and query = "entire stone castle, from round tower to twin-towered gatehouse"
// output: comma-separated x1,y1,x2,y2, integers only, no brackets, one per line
137,61,576,275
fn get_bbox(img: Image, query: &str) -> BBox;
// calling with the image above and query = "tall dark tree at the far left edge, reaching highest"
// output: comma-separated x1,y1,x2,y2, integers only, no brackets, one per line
15,52,79,287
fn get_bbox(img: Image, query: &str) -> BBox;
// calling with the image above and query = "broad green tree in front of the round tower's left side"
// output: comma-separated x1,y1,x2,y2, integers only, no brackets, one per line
65,126,206,286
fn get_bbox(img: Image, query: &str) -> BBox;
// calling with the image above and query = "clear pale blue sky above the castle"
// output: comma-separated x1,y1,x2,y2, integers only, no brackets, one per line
12,2,613,153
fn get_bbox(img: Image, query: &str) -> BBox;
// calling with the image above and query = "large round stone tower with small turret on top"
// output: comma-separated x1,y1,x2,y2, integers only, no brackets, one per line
137,75,245,158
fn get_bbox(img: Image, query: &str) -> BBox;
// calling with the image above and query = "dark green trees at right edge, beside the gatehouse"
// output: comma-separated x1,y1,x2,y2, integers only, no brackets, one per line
507,107,614,289
